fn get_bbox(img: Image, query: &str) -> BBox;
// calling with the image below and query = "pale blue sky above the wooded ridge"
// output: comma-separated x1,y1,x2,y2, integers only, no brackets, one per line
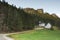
5,0,60,17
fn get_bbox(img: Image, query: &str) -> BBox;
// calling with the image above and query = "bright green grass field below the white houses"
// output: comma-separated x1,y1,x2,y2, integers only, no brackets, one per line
10,30,60,40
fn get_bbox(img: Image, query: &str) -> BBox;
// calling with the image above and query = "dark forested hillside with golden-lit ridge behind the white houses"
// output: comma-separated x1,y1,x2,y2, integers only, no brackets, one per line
0,1,60,32
